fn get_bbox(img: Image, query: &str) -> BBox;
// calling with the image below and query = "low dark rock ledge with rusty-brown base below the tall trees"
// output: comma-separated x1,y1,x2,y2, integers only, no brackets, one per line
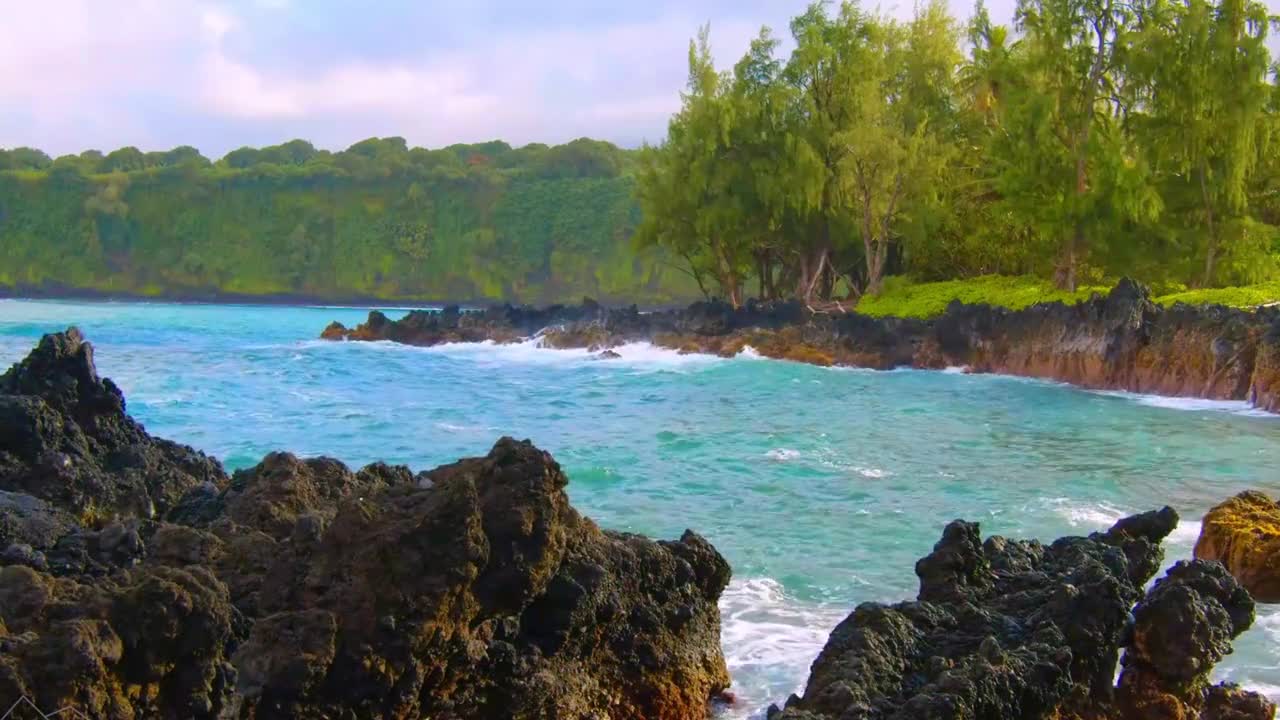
321,279,1280,413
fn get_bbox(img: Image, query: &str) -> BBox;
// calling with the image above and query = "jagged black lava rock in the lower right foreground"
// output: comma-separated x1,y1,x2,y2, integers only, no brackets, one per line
769,507,1275,720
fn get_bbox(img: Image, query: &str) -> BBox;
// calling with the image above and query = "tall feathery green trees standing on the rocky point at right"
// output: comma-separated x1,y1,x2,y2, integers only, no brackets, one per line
636,0,1280,307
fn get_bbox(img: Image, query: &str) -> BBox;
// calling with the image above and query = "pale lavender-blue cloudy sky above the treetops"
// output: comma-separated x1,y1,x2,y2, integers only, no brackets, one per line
0,0,1280,158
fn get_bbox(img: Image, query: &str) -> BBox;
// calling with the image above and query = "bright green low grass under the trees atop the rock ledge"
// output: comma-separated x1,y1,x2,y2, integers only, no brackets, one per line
858,275,1280,319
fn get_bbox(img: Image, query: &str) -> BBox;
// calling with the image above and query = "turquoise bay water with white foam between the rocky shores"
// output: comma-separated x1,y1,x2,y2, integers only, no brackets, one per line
0,300,1280,717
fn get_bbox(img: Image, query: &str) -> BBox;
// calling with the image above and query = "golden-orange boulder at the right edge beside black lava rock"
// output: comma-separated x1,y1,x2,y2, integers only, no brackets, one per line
1196,491,1280,602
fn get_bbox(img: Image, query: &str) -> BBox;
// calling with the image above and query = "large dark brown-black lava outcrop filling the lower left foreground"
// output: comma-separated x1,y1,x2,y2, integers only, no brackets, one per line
0,331,730,720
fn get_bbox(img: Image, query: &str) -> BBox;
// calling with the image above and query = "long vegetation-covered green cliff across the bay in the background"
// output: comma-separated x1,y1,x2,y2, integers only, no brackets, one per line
0,137,698,304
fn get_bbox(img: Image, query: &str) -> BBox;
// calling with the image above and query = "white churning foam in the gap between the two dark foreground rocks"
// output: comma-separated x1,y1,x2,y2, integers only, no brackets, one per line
719,578,850,719
